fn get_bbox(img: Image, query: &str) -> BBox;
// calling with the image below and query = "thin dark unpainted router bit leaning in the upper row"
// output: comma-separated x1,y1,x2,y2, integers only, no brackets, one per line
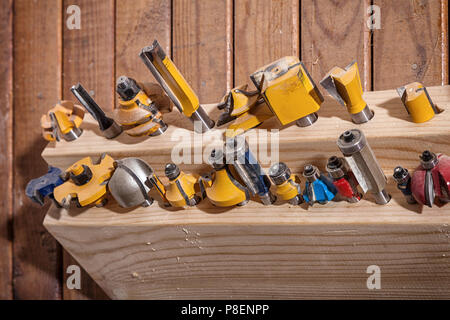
70,83,122,139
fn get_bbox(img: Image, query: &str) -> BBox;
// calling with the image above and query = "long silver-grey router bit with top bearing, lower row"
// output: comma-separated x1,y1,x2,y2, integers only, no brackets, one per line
337,129,391,204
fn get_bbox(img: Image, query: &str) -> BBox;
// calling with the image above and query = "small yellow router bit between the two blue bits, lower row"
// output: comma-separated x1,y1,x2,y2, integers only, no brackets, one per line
269,162,303,205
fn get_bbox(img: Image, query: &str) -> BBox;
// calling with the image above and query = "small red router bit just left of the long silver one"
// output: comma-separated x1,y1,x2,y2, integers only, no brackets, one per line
327,156,362,203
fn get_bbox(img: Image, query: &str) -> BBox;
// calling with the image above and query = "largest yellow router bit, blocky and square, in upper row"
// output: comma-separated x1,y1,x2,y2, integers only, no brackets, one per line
250,56,323,127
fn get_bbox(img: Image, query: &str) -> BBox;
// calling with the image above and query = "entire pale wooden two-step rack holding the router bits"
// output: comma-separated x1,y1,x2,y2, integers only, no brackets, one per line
43,86,450,299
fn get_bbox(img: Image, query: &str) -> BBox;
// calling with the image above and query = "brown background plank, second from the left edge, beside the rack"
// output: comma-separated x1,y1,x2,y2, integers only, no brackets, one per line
13,0,62,299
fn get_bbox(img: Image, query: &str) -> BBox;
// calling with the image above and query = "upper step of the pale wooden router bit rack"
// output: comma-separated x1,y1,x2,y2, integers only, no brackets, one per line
42,86,450,175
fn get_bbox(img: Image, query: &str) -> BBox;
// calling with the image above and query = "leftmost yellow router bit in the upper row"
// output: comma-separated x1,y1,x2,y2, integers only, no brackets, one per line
41,100,84,141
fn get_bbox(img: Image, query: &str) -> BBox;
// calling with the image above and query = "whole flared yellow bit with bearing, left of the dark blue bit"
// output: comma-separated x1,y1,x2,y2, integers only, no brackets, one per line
200,149,250,207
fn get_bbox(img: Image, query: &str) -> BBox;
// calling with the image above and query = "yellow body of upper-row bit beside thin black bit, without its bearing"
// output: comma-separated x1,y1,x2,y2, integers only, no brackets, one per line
114,90,162,137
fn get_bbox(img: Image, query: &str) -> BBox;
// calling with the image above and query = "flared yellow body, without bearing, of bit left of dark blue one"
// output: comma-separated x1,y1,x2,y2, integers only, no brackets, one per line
201,168,248,207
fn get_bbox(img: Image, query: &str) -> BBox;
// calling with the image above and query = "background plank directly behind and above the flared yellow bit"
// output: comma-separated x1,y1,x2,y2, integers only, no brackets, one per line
300,0,371,90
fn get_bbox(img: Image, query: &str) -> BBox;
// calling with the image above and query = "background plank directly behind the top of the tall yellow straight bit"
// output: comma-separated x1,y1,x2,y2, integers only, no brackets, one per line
116,0,171,89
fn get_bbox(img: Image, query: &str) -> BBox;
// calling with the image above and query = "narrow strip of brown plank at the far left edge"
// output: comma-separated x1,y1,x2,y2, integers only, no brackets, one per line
0,0,13,300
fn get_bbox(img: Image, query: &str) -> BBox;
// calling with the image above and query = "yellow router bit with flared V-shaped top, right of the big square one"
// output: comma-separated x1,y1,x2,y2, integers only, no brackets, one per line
320,61,374,124
